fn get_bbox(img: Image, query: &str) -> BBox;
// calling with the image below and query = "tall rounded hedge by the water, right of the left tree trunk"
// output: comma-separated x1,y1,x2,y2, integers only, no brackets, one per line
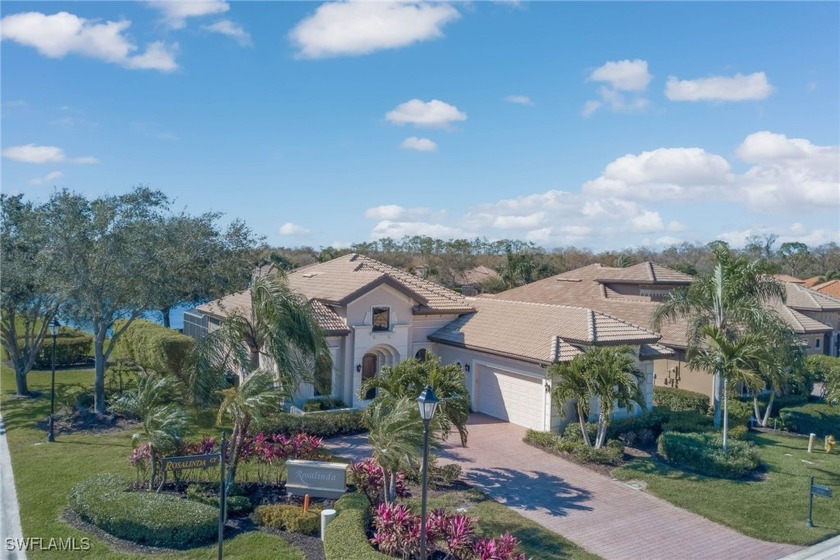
117,319,195,377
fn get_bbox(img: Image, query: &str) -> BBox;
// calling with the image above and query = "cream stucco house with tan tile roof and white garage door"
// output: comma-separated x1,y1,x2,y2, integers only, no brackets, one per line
184,254,670,430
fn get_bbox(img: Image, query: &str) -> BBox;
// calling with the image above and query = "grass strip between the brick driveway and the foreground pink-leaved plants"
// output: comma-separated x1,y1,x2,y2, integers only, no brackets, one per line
406,490,599,560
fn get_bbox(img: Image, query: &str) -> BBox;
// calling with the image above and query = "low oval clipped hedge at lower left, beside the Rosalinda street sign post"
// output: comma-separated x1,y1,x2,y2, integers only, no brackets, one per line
70,474,219,548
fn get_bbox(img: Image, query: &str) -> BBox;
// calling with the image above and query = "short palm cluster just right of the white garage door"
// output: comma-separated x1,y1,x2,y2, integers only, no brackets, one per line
549,346,646,449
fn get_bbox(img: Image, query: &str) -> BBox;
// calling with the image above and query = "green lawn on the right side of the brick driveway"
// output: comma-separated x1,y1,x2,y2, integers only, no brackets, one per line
612,434,840,545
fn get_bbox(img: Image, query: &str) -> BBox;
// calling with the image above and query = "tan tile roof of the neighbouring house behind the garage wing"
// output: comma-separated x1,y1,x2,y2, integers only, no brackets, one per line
487,263,690,347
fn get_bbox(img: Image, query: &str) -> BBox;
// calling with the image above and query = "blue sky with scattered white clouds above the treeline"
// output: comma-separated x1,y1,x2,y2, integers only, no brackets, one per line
0,0,840,250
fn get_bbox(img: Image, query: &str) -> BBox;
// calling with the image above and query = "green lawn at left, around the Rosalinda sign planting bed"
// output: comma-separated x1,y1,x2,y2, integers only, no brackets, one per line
0,366,303,560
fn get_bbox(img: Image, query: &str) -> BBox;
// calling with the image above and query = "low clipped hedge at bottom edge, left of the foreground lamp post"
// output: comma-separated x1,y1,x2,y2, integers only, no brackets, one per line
324,493,390,560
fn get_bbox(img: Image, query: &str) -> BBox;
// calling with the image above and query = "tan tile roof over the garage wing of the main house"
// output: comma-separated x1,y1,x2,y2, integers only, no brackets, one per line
429,298,659,363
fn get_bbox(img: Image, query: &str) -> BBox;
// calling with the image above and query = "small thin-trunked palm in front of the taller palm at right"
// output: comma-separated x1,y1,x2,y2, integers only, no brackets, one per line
688,326,767,451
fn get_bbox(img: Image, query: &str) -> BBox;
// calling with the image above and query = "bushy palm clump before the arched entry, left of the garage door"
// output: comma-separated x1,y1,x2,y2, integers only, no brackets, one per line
359,354,470,446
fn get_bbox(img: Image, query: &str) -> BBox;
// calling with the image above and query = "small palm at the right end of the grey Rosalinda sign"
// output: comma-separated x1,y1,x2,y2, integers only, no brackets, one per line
366,396,423,502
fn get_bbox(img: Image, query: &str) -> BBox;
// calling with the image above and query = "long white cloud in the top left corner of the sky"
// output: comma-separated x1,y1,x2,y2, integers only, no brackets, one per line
0,12,178,72
